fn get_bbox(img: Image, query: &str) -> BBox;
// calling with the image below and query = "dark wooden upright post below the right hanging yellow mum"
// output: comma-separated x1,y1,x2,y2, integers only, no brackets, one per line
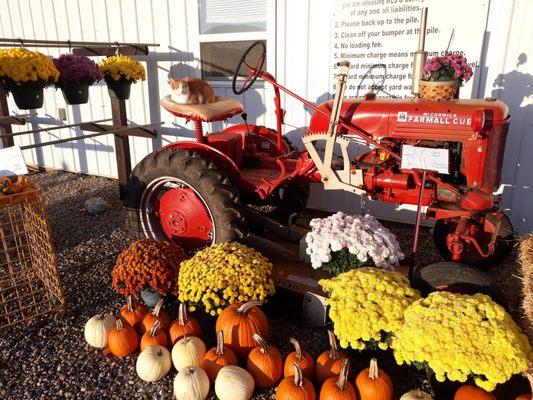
111,97,131,199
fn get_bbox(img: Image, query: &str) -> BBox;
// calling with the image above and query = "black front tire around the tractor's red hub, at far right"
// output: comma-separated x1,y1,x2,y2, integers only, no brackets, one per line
433,214,514,269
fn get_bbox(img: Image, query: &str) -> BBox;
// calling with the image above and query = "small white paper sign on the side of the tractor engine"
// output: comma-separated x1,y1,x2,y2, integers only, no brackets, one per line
400,144,450,174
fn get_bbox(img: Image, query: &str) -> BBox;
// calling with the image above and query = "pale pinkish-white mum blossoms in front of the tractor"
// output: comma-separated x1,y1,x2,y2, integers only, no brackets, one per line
306,212,404,270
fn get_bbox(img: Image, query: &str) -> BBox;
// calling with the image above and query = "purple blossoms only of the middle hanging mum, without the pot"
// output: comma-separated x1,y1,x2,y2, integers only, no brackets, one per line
54,54,102,88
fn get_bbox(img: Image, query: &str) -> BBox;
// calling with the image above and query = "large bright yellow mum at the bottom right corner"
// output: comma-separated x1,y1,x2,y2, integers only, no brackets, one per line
393,292,531,391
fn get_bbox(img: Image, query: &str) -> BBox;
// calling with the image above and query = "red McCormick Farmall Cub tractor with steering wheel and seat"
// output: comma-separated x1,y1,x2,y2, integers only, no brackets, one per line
125,14,513,266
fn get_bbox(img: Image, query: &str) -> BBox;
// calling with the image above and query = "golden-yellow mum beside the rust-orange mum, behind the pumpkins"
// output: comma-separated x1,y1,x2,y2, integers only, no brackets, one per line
178,242,275,316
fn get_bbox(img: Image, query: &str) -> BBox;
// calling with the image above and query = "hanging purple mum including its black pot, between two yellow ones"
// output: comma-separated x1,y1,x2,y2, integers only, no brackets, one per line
54,54,102,104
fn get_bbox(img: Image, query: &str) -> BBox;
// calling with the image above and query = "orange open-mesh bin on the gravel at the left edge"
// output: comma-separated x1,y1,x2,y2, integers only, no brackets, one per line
0,185,65,329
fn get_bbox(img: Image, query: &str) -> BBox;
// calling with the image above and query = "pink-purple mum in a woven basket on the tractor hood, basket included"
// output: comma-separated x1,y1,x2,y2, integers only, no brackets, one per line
420,54,473,101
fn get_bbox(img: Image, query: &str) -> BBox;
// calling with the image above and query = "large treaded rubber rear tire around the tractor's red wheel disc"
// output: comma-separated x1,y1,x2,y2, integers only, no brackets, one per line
124,149,247,250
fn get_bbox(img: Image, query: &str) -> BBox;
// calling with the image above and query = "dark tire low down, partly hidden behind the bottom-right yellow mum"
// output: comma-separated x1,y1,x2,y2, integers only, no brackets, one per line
413,262,507,307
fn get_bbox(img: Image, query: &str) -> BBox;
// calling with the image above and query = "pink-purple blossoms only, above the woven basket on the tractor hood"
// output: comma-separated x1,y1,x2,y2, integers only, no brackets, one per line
424,54,473,86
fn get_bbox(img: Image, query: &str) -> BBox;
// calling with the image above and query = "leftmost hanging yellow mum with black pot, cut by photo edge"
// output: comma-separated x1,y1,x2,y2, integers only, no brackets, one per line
0,48,59,110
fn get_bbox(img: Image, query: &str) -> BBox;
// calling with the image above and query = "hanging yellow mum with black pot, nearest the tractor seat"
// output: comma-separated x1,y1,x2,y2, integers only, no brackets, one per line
100,54,146,100
